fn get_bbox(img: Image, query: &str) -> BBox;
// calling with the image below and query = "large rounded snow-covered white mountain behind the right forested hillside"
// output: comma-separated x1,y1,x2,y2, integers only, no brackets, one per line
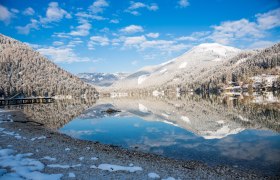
112,43,241,89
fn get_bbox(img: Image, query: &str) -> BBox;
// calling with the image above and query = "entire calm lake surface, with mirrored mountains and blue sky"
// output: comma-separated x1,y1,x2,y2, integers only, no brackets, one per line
1,93,280,174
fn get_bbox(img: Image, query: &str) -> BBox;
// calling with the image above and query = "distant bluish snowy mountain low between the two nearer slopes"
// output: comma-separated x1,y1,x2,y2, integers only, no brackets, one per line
77,73,128,86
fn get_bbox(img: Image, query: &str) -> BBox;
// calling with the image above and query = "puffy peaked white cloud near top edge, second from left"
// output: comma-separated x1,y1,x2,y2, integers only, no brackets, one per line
41,2,72,23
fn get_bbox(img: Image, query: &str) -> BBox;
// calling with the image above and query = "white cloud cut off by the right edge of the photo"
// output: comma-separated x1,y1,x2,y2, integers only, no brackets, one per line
256,8,280,29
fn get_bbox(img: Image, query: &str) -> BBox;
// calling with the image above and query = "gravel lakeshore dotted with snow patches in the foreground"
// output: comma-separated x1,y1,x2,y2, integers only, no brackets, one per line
0,111,263,180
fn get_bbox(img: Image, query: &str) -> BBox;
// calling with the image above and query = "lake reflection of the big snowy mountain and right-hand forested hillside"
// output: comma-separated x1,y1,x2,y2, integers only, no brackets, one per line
89,97,280,139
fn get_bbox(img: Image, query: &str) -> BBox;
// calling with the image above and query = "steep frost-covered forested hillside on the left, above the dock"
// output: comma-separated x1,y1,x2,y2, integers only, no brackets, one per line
0,34,97,97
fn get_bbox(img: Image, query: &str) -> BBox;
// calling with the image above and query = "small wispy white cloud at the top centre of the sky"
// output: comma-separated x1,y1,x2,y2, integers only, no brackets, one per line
125,1,159,16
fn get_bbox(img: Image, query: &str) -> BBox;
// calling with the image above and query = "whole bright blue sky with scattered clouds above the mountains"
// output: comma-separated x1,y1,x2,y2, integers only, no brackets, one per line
0,0,280,74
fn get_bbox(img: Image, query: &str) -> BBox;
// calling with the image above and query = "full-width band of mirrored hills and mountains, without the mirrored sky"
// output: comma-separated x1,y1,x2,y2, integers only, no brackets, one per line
3,93,280,139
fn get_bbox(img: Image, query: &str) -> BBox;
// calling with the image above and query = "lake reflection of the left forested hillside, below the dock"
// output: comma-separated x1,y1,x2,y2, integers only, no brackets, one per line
2,99,96,129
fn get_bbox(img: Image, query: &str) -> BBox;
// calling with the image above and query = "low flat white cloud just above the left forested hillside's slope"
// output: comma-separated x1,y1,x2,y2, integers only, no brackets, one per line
37,47,90,63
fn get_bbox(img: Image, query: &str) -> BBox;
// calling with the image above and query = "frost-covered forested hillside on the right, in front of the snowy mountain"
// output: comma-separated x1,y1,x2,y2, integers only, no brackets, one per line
186,43,280,91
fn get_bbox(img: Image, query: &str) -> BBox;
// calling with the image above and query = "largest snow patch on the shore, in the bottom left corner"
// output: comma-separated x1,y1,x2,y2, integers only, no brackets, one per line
0,149,63,180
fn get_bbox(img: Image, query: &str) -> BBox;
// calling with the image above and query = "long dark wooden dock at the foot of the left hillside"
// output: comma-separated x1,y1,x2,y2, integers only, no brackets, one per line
0,97,54,106
